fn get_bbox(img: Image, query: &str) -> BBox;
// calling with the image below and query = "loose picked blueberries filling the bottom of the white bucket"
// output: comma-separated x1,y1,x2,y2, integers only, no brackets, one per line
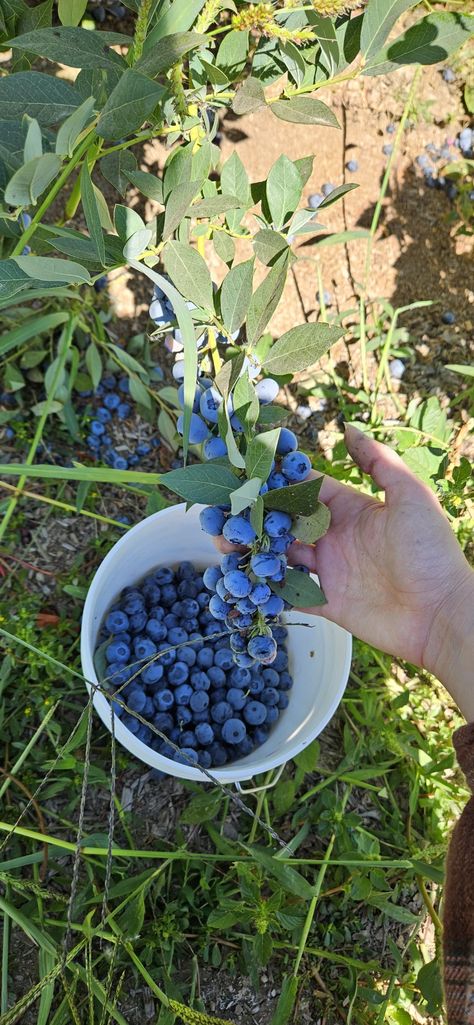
98,557,292,769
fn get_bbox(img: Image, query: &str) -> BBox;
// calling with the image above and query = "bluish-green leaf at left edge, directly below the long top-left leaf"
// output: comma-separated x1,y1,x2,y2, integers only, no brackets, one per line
0,71,81,125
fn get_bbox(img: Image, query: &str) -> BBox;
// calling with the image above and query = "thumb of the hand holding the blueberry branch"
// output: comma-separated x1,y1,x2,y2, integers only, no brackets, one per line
344,423,427,499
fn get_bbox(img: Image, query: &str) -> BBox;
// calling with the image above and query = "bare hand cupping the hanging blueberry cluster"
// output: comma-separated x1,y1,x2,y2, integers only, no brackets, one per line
215,426,474,718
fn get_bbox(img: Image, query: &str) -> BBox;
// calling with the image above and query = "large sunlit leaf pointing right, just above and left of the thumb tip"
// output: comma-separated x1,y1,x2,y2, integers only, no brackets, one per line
264,324,344,376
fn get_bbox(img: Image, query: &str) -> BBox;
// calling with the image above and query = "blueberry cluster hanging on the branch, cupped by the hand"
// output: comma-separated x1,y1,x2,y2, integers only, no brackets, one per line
196,427,311,668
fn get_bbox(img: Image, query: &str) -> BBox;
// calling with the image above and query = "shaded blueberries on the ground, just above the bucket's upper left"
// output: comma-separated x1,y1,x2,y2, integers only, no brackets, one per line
81,374,161,469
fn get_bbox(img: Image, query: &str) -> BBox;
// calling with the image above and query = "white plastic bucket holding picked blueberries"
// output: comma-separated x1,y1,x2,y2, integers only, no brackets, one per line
81,504,352,783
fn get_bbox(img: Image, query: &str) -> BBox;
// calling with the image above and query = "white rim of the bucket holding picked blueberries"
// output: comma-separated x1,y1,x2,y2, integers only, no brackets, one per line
81,502,352,783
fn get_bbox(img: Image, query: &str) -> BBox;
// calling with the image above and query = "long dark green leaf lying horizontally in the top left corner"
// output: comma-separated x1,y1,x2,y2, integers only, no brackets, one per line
8,26,132,69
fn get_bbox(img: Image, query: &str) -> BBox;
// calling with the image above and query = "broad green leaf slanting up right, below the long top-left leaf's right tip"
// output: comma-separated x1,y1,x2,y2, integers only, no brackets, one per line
96,69,164,139
